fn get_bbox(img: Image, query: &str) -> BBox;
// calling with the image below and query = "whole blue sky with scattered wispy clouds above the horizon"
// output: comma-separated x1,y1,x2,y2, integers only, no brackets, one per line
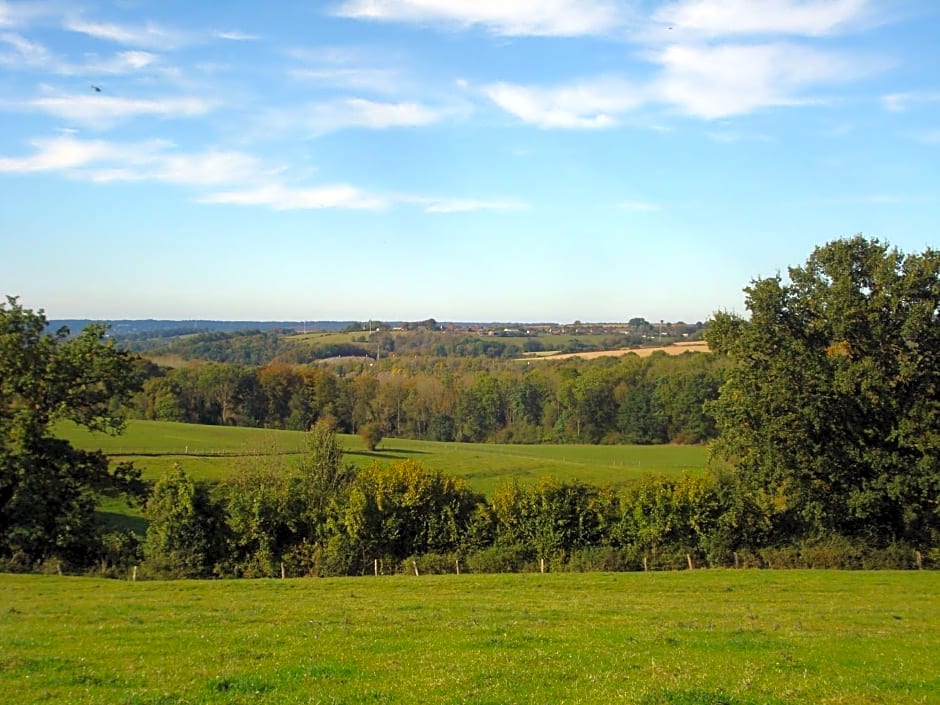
0,0,940,322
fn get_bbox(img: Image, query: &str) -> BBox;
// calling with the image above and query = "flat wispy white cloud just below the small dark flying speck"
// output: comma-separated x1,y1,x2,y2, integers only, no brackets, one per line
19,93,215,129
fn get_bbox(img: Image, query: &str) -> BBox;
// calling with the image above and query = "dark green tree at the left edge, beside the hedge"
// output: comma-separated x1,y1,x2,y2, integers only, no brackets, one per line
0,297,143,565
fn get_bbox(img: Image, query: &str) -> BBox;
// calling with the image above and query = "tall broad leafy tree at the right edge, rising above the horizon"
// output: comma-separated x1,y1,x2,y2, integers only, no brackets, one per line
707,235,940,545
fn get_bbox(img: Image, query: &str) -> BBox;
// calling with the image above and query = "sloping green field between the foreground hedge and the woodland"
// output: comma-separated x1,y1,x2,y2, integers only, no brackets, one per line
57,421,706,493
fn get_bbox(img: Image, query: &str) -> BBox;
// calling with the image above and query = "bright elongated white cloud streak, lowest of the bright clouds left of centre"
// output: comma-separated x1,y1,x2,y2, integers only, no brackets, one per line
198,184,388,210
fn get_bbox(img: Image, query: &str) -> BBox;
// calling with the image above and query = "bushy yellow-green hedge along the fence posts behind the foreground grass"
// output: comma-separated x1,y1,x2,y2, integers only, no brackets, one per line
111,421,940,578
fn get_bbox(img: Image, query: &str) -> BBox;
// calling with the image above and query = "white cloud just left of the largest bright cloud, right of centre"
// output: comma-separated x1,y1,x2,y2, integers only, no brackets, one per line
484,78,645,129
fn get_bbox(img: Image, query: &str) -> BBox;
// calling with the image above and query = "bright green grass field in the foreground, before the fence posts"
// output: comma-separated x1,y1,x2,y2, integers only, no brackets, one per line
0,571,940,705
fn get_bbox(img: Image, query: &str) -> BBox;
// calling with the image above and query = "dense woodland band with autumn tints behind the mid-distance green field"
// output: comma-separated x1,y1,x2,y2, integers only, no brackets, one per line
131,353,727,444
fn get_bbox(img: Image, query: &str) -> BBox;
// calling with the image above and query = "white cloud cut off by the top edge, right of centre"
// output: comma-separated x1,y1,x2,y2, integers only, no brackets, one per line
653,0,872,37
